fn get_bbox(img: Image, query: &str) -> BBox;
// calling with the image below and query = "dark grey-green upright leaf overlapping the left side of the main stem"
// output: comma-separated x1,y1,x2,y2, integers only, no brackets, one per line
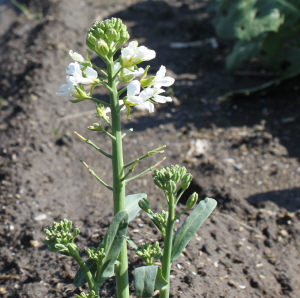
74,211,128,287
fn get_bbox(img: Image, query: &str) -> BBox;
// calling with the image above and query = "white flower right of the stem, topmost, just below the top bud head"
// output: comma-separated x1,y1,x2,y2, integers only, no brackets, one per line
121,41,156,67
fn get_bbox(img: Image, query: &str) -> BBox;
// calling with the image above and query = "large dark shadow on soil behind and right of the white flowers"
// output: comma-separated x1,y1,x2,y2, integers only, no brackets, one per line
108,1,300,158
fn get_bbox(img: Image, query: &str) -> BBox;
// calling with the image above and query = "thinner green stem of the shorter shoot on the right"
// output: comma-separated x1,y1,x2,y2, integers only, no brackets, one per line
159,196,175,298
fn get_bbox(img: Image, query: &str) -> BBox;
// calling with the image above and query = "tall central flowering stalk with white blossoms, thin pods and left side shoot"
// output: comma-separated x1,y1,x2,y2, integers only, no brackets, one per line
46,18,178,298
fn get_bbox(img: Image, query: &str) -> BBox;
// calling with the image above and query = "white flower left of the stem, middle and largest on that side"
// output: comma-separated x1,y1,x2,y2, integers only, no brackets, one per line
66,62,98,84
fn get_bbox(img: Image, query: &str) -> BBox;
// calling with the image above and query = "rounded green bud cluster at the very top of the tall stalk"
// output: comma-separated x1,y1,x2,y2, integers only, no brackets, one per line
86,18,129,57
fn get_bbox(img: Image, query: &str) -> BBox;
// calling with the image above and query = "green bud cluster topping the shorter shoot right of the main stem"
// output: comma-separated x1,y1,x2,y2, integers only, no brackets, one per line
153,165,193,195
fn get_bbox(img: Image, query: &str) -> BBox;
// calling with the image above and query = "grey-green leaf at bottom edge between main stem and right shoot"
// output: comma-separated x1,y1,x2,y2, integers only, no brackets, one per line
134,266,158,297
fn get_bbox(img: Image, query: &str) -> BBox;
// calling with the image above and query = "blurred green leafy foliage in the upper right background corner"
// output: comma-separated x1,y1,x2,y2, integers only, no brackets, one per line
213,0,300,76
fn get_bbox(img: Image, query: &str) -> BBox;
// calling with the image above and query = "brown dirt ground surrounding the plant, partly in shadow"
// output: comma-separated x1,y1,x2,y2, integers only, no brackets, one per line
0,0,300,298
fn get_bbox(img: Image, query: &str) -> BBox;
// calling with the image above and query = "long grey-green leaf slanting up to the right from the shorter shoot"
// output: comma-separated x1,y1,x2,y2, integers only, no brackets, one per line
171,198,217,261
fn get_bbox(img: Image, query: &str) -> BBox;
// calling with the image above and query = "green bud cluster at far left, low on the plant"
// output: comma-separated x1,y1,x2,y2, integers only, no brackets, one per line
45,219,79,255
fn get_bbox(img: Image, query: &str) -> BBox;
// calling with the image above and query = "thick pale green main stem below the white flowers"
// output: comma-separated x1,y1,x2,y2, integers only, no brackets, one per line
107,58,129,298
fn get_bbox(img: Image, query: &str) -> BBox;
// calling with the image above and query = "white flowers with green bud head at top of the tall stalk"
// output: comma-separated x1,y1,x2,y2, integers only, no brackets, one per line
57,19,174,116
